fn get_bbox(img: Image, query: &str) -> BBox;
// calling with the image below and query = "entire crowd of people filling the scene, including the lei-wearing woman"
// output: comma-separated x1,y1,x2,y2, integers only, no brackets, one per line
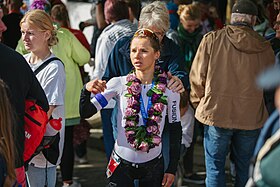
0,0,280,187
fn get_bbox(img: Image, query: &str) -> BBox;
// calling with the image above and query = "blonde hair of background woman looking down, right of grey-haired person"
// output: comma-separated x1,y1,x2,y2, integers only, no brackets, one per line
177,4,201,21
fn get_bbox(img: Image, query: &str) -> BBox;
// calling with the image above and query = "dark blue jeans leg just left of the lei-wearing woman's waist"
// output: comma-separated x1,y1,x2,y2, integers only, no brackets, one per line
100,109,115,160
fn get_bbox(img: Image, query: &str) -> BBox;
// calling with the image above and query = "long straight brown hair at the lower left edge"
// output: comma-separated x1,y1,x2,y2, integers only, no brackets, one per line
0,79,16,186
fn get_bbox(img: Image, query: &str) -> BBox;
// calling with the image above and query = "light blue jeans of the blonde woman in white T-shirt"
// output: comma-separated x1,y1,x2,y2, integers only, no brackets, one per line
26,165,56,187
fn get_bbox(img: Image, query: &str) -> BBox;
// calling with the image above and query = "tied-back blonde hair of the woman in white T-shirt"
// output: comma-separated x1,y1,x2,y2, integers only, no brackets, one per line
20,9,58,46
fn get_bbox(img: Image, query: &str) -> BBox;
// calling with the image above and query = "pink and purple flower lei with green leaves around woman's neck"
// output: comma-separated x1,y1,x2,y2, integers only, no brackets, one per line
124,66,167,152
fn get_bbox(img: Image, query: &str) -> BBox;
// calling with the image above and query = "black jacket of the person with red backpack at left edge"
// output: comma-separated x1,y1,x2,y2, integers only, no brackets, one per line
0,43,49,168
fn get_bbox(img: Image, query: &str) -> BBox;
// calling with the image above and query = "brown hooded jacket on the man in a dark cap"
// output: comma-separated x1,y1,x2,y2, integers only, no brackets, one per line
190,25,274,130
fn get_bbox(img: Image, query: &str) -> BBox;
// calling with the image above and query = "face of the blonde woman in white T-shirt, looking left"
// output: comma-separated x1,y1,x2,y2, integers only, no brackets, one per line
21,22,50,52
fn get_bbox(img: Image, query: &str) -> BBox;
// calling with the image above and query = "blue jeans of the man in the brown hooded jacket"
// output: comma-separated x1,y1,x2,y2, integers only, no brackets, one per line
204,125,260,187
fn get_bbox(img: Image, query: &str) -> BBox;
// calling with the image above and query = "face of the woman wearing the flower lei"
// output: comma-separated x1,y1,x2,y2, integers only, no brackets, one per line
130,37,160,71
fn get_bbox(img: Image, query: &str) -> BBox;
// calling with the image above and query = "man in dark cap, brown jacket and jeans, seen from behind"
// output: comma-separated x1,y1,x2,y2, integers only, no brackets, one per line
190,0,274,187
